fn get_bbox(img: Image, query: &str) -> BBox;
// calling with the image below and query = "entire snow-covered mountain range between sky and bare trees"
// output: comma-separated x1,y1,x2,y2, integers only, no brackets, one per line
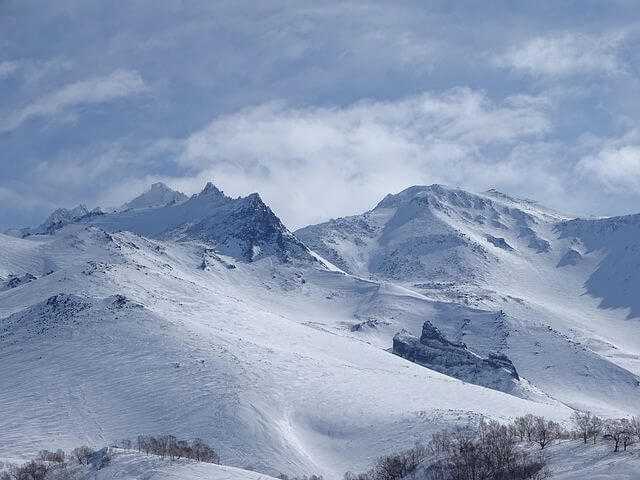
0,184,640,479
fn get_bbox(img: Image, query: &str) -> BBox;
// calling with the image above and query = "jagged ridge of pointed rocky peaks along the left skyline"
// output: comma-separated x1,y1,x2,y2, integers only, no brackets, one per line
6,182,315,262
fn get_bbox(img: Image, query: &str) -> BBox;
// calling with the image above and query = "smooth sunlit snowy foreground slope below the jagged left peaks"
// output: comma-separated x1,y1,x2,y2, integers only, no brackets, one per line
0,225,568,478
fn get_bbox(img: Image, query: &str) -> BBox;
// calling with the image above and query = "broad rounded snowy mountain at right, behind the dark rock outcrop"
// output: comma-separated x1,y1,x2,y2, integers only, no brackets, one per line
296,185,640,411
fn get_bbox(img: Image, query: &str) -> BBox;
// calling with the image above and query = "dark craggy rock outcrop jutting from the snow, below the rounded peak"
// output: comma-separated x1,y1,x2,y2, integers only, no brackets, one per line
393,321,520,393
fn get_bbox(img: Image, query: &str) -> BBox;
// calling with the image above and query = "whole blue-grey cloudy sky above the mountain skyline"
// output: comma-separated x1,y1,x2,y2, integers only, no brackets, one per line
0,0,640,230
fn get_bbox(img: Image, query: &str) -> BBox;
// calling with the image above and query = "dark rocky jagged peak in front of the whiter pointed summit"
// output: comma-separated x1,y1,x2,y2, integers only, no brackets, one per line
86,183,314,262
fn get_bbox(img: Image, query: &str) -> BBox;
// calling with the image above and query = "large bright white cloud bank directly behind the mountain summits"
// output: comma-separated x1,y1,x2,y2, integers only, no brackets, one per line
178,88,551,226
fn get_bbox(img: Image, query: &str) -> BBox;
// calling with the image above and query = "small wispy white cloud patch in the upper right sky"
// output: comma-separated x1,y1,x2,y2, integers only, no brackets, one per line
494,32,625,77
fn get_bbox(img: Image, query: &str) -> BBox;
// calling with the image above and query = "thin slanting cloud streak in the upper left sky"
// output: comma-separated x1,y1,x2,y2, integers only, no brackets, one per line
0,70,146,132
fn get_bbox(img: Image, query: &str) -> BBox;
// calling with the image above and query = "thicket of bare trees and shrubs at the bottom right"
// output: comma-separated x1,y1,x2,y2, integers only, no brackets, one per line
344,412,640,480
